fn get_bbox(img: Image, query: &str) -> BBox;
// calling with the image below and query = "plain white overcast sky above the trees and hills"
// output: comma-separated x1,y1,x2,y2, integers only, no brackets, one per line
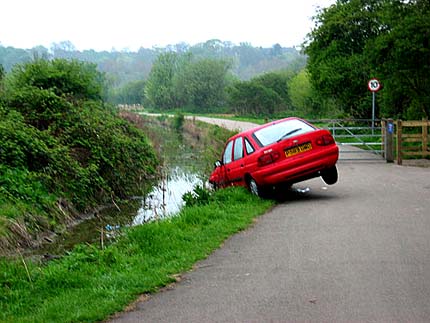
0,0,335,51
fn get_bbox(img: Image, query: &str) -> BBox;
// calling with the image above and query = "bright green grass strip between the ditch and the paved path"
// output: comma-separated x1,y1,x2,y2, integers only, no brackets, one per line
0,188,273,322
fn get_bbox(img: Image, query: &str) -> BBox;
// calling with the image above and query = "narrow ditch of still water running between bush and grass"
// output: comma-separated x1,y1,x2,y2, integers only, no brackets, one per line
35,117,207,256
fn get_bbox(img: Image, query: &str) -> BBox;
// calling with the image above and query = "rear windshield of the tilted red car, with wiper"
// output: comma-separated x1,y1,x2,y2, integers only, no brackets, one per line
253,119,315,147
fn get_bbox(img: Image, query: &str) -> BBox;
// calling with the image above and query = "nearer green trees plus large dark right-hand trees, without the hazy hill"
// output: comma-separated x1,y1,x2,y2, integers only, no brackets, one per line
112,0,430,119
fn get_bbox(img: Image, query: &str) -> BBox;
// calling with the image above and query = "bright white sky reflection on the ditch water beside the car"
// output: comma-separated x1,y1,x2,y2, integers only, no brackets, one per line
132,167,201,225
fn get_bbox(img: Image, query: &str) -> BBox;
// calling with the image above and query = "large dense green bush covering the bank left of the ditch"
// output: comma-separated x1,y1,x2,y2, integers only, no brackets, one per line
0,60,157,248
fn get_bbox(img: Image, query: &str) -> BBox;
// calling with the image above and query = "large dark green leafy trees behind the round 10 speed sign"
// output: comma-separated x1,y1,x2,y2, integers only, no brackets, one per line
305,0,430,118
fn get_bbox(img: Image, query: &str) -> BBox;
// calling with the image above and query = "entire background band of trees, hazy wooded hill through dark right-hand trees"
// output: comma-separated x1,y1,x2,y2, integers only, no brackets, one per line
0,0,430,119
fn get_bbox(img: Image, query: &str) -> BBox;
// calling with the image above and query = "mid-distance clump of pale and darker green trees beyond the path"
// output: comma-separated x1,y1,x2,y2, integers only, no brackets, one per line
140,52,306,116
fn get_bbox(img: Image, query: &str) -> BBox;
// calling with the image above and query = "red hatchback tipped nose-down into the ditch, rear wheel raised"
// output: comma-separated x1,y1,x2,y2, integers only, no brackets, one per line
209,118,339,196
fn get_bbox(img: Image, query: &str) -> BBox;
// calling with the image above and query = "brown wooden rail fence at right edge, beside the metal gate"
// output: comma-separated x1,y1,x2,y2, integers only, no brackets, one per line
396,120,430,165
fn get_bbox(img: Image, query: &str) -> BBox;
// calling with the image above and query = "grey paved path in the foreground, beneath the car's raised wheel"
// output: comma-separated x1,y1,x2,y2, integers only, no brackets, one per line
112,118,430,322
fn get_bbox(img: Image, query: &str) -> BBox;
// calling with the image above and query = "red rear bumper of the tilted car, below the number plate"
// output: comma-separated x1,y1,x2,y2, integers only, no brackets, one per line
251,146,339,185
